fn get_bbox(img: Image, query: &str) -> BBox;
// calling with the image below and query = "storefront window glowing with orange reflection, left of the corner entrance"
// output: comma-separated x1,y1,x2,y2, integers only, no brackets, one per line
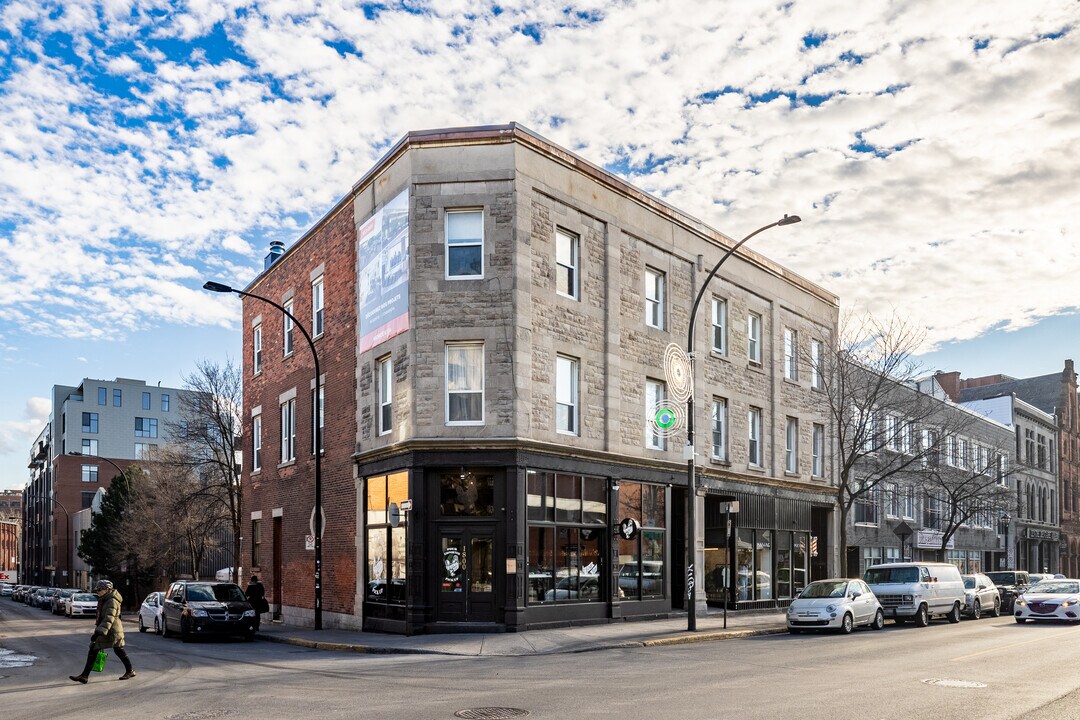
365,472,408,604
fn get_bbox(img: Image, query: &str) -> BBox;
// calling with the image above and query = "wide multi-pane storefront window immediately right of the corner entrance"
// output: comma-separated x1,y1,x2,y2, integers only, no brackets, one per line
525,471,609,604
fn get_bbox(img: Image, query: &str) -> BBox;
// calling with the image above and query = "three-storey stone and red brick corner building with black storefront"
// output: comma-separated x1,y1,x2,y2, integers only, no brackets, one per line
243,124,838,634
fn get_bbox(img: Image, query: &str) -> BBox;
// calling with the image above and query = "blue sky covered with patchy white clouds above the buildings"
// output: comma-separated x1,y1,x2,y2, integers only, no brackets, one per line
0,0,1080,487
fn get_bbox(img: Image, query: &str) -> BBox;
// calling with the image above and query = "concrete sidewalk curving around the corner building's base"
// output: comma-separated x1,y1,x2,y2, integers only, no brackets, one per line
247,610,786,656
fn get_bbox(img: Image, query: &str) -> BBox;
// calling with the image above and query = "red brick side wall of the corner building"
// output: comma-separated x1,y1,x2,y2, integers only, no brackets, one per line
242,202,356,615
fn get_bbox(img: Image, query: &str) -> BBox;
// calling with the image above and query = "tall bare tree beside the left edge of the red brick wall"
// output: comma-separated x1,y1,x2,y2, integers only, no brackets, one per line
170,361,243,583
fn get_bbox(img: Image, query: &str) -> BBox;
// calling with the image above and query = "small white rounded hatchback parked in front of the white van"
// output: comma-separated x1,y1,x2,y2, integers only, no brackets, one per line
787,578,885,635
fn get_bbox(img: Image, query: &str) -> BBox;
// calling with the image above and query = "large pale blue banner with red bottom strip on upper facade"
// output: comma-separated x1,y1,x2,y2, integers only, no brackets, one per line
356,190,408,352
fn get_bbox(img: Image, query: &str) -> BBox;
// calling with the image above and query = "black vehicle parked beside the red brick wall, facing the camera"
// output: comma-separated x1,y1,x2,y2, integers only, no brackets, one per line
162,580,255,642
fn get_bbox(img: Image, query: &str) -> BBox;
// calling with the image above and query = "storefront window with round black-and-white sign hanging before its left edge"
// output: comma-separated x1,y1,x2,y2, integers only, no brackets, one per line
616,483,667,600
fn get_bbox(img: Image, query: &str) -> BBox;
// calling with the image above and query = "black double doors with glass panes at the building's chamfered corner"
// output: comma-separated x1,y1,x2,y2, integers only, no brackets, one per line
436,525,496,623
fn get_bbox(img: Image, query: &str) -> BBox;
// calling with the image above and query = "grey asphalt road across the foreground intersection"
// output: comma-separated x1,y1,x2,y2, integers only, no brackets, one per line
0,598,1080,720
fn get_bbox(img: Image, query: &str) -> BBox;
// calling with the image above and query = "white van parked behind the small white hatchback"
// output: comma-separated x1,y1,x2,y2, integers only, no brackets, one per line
863,562,964,627
